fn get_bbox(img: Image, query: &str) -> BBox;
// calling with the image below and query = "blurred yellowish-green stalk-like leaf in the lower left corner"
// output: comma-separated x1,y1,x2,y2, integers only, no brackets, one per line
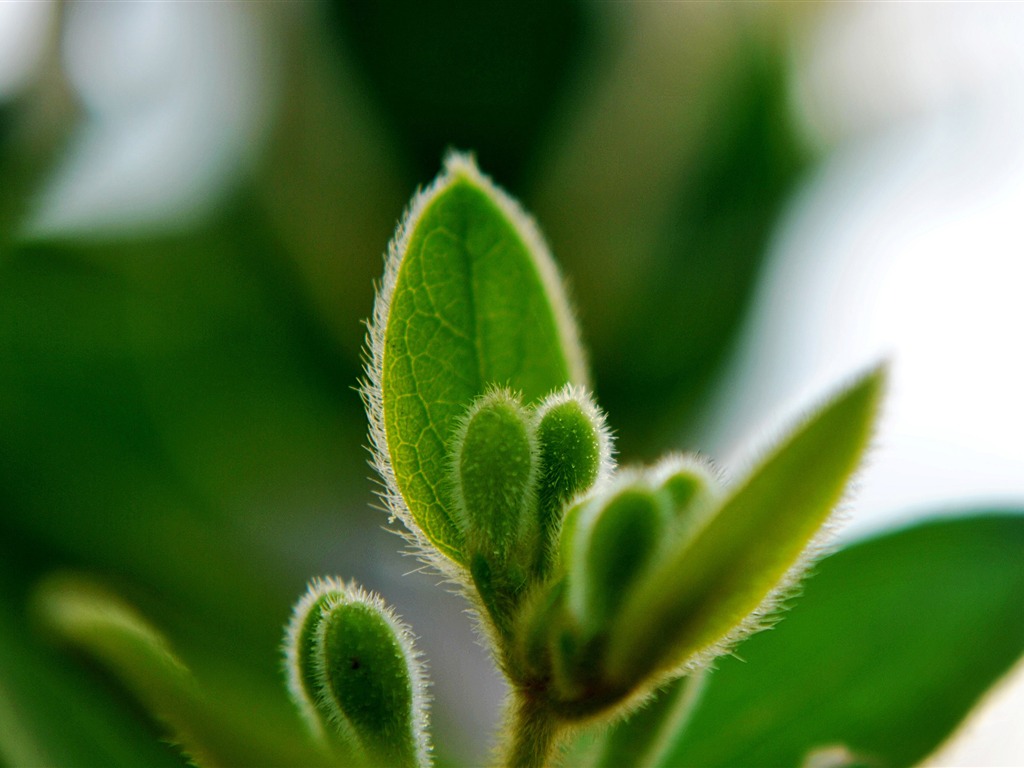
34,574,328,766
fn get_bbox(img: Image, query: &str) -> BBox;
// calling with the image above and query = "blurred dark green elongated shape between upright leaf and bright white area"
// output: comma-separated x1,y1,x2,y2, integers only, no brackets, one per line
614,43,809,452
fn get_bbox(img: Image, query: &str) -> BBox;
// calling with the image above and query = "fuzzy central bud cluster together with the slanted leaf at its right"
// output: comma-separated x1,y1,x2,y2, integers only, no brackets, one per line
452,371,883,721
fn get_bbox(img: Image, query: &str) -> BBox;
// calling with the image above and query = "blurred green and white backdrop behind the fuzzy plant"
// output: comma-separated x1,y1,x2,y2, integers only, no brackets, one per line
0,0,1024,766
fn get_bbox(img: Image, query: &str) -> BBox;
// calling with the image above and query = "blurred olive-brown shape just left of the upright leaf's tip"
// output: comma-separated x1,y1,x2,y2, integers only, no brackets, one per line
253,8,405,360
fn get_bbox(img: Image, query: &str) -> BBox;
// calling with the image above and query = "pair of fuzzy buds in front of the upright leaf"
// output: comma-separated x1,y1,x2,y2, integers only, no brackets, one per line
451,387,611,640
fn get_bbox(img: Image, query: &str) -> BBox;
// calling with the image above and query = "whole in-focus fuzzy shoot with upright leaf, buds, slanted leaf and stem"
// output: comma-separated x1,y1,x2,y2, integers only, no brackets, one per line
317,154,884,766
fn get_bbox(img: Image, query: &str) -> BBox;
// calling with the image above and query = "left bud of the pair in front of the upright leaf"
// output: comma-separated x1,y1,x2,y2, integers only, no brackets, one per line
453,389,537,569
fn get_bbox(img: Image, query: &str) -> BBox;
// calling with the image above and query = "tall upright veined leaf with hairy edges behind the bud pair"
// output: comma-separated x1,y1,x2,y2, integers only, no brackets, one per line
364,155,584,564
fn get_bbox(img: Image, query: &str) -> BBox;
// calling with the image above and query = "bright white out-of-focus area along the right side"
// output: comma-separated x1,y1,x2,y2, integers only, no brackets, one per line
705,3,1024,766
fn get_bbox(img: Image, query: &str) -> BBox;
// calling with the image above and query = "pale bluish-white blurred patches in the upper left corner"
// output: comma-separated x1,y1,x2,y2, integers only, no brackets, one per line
0,0,275,238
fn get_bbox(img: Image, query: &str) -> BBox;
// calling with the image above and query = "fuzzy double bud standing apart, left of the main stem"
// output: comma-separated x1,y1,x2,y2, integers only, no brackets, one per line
286,580,429,768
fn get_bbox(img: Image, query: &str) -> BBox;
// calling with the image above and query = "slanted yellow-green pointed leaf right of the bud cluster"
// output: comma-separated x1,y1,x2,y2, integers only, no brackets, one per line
607,369,885,685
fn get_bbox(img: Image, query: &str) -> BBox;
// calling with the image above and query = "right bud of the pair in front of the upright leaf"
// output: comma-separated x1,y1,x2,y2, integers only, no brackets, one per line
537,385,611,574
